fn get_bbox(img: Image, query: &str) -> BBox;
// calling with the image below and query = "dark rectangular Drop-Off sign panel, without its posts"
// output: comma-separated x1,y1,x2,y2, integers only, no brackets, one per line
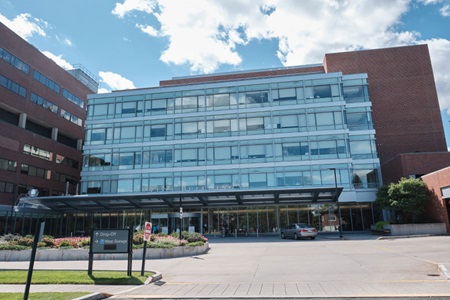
91,229,131,253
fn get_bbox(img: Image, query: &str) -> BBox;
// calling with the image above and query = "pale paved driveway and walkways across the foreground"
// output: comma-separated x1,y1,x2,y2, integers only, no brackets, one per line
0,235,450,299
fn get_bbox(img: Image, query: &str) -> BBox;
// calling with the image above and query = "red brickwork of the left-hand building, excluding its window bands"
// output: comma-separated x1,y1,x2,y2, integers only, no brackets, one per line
0,23,93,204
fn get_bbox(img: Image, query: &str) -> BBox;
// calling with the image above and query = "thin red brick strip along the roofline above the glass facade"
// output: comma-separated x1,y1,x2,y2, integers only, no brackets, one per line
159,66,324,86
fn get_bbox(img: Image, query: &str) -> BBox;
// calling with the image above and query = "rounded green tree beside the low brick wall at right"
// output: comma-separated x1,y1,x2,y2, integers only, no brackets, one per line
376,178,430,223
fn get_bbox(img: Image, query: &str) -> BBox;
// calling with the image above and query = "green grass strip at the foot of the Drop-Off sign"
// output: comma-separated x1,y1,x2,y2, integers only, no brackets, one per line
0,270,153,286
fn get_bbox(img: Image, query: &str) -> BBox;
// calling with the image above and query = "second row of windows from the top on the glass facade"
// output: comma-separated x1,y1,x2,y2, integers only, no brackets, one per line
85,108,373,145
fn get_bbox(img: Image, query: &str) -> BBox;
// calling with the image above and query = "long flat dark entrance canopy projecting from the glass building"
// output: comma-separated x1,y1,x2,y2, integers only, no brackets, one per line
16,187,343,213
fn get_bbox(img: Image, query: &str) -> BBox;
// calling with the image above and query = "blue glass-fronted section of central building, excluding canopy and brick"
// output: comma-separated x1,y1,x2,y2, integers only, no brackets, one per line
80,72,381,235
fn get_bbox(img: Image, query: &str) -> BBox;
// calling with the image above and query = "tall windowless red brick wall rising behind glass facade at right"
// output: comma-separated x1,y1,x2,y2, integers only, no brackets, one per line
324,45,447,164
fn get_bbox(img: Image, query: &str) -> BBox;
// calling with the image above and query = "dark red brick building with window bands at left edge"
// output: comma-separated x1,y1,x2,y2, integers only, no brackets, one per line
0,23,98,233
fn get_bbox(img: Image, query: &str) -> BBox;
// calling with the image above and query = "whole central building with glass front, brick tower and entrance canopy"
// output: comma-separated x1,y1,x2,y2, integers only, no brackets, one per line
10,45,450,236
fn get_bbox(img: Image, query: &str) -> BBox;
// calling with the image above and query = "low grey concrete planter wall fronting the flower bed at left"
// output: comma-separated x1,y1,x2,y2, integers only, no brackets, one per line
0,243,209,261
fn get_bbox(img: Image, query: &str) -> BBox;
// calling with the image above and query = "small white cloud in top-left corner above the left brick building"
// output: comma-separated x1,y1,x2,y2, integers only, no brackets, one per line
0,13,48,40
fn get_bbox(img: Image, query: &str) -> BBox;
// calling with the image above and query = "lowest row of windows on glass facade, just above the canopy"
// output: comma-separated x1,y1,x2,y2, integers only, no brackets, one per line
82,165,379,194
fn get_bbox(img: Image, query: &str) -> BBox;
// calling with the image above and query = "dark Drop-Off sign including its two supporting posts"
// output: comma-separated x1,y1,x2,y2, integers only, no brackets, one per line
88,228,133,276
